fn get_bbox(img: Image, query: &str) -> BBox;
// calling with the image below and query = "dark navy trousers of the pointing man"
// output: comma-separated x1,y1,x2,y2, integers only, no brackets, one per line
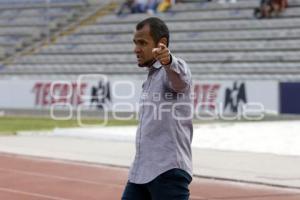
122,169,192,200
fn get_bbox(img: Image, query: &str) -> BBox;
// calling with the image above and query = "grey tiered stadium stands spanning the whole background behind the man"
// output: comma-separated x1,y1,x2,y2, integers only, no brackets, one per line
0,0,300,80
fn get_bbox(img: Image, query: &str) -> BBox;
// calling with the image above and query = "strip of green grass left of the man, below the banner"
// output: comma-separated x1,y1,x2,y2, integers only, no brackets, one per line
0,117,137,135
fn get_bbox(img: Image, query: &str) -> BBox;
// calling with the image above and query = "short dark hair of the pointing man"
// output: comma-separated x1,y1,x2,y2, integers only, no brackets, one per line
136,17,170,47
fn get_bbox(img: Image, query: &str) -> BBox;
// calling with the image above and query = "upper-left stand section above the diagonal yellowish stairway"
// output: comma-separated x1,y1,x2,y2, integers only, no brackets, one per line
0,0,90,58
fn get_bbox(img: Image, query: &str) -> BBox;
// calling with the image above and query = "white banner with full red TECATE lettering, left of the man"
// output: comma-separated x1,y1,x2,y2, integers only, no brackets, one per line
0,75,142,111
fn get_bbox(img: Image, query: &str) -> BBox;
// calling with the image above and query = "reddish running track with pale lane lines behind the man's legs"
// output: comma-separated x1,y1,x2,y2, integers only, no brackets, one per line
0,153,300,200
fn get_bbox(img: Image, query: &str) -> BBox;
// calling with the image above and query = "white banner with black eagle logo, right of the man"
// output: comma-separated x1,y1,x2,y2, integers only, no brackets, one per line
193,81,278,119
